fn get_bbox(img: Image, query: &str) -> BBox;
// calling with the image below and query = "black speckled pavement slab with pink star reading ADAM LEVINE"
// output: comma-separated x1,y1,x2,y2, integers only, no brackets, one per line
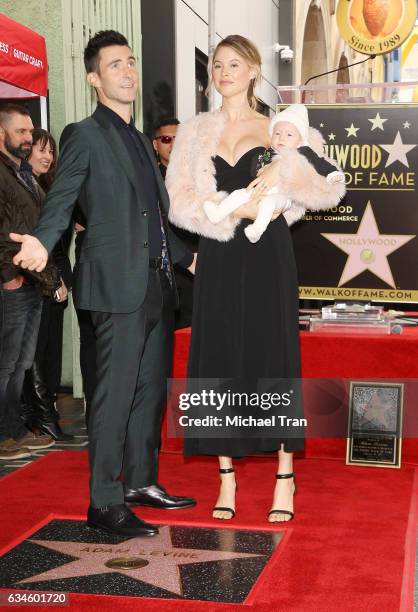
0,520,283,602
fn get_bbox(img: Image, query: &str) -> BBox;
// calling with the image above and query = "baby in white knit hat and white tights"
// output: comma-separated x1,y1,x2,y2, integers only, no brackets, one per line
203,104,344,242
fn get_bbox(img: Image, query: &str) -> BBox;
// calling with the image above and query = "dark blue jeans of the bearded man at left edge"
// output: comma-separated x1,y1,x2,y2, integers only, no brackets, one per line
0,283,42,441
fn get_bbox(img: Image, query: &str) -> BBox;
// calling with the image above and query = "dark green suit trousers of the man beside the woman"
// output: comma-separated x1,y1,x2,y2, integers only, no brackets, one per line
89,269,174,507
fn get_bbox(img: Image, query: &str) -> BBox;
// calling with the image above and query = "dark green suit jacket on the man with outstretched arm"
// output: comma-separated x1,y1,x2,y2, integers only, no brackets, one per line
34,107,187,313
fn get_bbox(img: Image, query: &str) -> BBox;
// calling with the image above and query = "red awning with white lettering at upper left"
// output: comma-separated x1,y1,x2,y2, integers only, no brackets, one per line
0,13,48,98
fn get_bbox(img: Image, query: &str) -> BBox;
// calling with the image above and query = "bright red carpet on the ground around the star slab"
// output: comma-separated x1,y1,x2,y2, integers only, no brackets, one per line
0,452,416,612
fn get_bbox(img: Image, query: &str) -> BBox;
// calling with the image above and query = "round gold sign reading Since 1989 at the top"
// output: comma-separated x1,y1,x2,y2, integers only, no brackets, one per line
337,0,417,55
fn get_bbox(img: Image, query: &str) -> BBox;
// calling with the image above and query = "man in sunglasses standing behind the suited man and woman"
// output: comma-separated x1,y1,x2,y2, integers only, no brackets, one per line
152,117,199,329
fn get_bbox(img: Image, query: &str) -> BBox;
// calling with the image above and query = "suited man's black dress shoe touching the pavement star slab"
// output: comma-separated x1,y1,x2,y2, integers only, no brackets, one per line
87,504,158,538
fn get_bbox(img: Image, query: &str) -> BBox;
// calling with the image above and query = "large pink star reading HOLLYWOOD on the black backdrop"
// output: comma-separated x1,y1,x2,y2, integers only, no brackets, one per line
322,202,415,287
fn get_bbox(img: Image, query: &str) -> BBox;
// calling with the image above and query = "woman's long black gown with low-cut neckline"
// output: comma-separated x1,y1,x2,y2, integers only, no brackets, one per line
184,147,303,457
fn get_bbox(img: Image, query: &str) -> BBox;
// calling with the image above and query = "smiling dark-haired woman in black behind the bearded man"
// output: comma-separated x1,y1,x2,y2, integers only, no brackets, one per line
22,128,73,442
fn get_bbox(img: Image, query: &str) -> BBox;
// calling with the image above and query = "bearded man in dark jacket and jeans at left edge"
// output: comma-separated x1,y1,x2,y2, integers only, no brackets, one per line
0,104,55,460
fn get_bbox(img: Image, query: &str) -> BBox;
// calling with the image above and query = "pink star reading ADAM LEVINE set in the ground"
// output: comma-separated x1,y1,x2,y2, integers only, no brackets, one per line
17,526,264,595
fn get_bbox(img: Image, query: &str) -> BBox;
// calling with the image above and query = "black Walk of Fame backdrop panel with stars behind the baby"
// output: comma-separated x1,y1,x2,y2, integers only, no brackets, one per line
288,104,418,303
